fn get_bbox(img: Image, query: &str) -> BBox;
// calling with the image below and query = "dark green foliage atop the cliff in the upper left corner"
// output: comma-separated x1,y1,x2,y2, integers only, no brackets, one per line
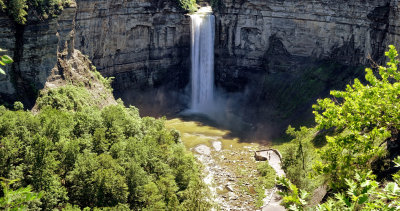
0,0,70,24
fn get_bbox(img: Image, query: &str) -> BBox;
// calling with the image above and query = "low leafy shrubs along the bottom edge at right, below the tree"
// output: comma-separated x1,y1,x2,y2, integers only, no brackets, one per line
278,165,400,211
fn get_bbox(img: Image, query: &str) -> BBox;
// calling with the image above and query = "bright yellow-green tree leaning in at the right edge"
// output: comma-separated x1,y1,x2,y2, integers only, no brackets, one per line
313,46,400,190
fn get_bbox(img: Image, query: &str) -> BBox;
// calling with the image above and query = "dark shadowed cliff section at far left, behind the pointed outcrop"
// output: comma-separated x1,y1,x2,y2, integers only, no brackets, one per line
0,3,76,104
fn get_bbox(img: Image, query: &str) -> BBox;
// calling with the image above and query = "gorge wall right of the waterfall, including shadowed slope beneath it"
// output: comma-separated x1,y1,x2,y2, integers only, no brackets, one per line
215,0,400,130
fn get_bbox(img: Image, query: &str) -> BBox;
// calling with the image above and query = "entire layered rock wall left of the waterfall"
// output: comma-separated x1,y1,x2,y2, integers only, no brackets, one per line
0,0,190,107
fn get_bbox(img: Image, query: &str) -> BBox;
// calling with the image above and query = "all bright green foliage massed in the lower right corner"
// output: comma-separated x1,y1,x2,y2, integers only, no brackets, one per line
280,46,400,210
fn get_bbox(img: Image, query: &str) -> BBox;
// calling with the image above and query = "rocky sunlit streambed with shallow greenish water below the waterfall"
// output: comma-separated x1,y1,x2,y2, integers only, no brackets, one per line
166,119,283,210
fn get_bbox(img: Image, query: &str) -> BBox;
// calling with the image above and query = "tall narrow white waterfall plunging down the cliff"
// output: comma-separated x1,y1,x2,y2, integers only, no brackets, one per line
190,7,215,113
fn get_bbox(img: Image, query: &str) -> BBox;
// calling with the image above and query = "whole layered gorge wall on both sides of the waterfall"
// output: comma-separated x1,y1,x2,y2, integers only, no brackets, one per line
0,0,400,118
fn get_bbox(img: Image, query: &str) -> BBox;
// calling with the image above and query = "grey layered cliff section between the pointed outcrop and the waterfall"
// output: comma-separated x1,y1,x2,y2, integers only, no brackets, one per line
75,0,190,91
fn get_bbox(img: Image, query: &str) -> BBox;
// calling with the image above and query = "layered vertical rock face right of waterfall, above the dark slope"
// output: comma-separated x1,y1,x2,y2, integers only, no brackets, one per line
212,0,398,89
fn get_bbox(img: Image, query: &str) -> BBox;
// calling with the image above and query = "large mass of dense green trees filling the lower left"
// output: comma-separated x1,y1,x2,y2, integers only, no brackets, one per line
0,87,210,210
